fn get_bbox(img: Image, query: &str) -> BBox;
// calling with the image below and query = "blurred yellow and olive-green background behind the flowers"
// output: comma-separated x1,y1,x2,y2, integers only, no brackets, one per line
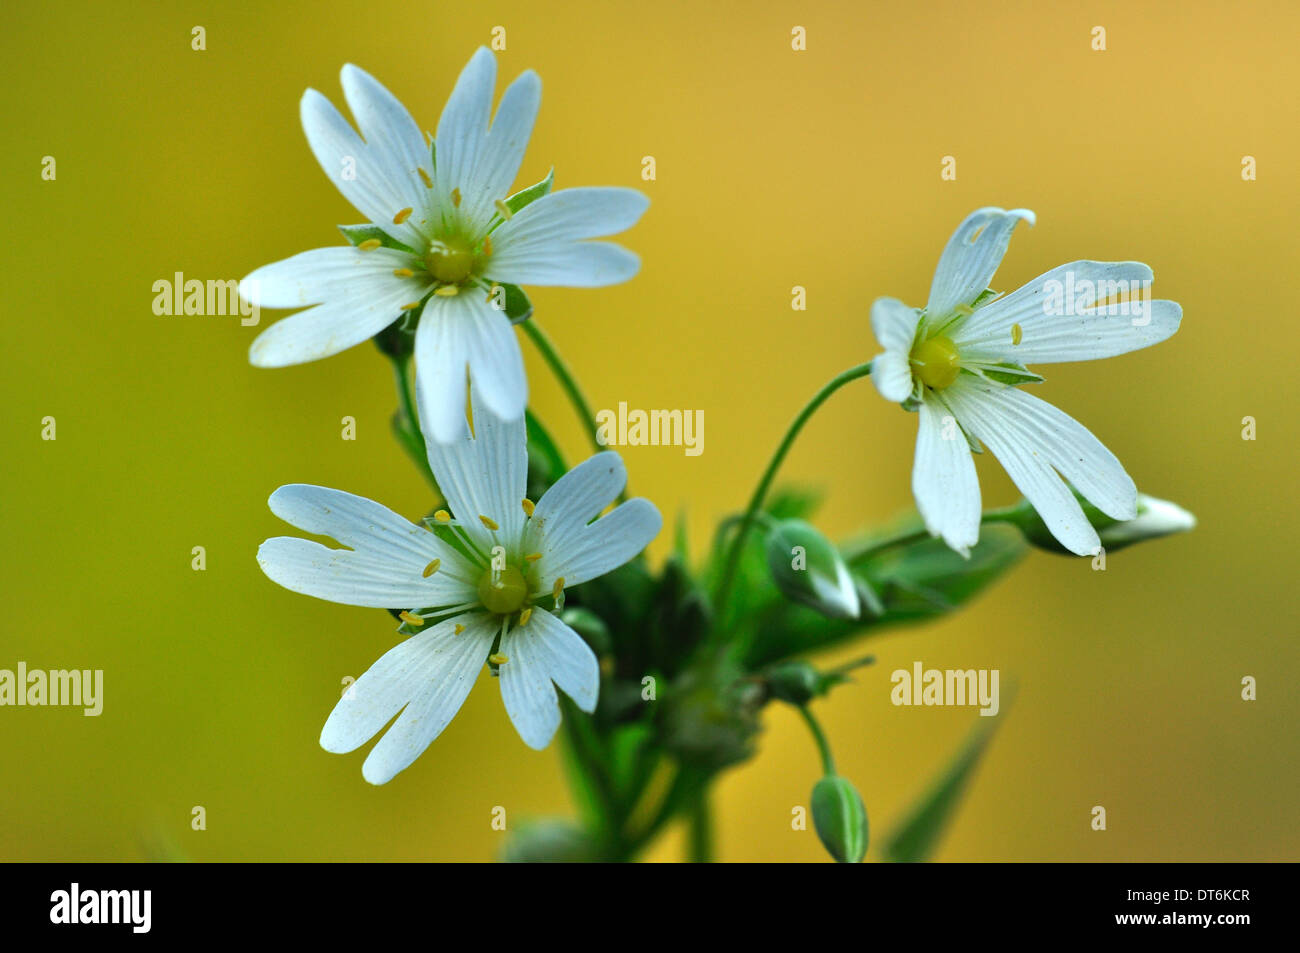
0,0,1300,861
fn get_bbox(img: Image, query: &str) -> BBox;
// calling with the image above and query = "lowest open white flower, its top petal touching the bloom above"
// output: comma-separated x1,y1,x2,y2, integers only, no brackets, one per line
257,389,660,784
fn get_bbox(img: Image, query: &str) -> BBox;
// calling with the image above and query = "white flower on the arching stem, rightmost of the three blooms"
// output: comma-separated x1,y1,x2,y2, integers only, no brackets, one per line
871,208,1183,555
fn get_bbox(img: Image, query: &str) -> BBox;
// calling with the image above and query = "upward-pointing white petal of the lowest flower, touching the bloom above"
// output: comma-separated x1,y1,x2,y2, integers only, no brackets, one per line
423,371,528,556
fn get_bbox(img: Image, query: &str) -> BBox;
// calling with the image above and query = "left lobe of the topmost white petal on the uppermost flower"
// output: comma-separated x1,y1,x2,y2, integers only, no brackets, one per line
434,47,506,230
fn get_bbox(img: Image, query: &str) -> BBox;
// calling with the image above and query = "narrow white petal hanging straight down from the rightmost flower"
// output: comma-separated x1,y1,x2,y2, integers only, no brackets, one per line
911,399,980,556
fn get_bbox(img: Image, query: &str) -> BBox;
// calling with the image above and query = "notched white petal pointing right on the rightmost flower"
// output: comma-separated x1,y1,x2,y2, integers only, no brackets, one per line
953,261,1183,364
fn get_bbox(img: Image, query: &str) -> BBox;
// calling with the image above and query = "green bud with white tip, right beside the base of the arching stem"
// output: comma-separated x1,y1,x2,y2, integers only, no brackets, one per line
764,520,861,619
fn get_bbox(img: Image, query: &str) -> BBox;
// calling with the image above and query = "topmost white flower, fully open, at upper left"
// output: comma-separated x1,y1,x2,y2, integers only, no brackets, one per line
241,48,649,442
